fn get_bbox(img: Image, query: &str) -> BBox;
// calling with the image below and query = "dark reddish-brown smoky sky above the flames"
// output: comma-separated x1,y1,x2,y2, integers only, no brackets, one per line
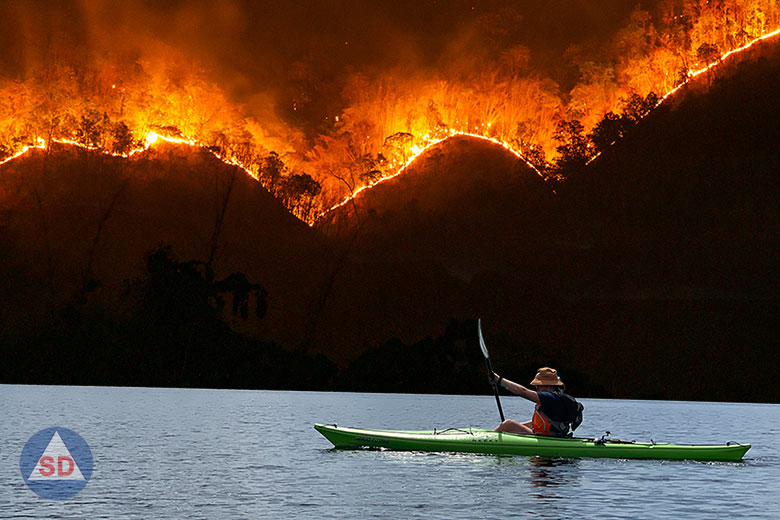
0,0,653,121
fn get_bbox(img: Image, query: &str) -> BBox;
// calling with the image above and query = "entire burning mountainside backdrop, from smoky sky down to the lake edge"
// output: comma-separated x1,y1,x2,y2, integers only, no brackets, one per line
0,0,780,400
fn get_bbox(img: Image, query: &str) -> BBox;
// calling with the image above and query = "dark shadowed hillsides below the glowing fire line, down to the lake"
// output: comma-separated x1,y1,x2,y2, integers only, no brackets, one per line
0,41,780,401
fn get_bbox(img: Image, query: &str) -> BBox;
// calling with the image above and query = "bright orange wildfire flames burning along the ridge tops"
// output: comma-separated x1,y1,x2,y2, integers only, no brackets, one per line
0,0,780,224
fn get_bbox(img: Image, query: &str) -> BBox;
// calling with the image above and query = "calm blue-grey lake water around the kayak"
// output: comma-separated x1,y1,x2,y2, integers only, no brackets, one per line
0,385,780,520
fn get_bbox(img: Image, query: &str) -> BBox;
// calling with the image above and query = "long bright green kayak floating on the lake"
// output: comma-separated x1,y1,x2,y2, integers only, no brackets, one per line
314,424,750,462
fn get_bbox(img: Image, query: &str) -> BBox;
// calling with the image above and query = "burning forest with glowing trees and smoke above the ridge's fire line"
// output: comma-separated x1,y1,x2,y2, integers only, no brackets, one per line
0,0,780,224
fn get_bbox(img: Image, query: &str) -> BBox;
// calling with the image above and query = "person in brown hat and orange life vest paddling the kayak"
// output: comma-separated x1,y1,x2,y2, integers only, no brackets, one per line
490,367,583,437
